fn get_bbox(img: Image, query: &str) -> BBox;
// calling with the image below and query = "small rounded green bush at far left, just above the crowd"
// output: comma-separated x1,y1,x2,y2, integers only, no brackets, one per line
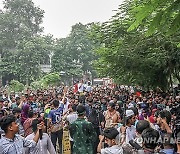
9,80,24,92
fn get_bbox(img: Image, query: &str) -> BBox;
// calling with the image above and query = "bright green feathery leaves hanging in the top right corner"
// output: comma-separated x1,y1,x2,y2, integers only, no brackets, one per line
128,0,180,36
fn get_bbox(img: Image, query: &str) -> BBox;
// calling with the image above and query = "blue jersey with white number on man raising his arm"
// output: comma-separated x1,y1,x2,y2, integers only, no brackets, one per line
48,104,64,124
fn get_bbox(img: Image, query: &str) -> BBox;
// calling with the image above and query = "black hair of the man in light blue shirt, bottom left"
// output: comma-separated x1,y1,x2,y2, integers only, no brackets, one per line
0,114,16,133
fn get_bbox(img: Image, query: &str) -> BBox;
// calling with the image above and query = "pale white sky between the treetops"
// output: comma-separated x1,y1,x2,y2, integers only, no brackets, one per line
0,0,123,38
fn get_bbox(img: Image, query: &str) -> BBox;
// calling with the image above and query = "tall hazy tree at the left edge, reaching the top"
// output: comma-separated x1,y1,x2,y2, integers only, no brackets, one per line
0,0,54,84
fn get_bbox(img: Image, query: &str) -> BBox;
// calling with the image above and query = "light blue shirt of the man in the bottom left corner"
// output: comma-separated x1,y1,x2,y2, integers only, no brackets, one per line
0,134,36,154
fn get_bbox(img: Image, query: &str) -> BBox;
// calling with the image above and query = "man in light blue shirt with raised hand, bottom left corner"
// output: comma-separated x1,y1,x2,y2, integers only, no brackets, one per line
0,115,43,154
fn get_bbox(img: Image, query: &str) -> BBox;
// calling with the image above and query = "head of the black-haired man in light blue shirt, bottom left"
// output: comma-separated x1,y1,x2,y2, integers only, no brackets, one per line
0,115,19,134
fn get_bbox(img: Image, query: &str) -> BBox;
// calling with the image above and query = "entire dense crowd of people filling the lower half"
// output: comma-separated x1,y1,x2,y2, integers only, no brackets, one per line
0,81,180,154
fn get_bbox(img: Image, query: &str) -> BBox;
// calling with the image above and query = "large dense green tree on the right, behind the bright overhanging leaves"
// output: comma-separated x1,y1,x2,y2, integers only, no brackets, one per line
91,0,180,90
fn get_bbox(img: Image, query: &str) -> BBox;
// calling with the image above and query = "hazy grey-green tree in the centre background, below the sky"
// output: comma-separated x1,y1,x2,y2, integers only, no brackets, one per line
52,23,97,77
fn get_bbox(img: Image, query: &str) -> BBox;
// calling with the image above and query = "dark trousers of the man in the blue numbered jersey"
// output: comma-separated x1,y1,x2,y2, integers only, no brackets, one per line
51,129,63,154
